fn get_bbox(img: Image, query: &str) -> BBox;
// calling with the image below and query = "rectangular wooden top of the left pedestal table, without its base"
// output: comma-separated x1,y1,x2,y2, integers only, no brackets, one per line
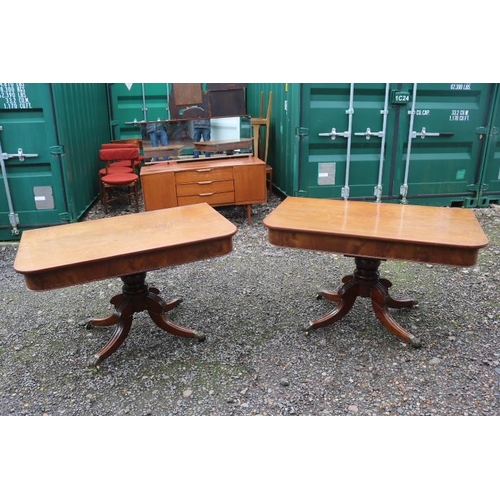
14,203,237,290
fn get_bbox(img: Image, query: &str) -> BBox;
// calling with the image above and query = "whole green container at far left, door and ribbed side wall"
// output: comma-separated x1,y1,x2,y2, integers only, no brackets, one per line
0,83,111,241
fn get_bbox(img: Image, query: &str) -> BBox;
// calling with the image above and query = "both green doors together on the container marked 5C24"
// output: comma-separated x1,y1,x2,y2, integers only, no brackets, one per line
298,83,496,206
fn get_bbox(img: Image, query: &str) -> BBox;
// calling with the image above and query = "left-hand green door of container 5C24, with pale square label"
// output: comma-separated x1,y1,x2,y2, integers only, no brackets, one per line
299,83,396,199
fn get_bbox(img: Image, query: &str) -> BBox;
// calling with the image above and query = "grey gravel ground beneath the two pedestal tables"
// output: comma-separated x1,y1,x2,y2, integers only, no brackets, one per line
0,191,500,416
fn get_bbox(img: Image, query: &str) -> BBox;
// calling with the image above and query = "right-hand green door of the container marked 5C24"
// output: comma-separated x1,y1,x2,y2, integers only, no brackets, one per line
393,83,495,207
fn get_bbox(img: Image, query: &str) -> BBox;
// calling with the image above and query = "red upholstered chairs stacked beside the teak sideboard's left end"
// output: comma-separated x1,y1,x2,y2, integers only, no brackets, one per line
99,147,139,213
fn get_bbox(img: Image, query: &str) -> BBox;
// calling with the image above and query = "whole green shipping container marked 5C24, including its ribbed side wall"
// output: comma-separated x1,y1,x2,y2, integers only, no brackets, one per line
247,83,500,207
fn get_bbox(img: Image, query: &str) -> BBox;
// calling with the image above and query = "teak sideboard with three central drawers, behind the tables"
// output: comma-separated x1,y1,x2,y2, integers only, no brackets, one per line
141,156,267,223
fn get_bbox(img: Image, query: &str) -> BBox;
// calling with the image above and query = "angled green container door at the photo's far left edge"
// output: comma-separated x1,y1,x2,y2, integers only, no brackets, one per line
0,83,68,241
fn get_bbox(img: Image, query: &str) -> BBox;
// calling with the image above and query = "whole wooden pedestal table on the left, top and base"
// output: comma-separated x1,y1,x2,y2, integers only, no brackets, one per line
14,203,236,366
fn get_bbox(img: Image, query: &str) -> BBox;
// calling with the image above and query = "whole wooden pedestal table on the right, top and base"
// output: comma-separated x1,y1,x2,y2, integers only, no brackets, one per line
263,197,488,347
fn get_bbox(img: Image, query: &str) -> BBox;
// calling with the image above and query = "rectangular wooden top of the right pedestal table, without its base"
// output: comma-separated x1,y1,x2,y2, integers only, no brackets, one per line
263,197,488,266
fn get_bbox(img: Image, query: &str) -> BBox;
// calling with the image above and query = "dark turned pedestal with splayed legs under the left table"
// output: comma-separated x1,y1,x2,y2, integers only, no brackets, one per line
89,273,205,366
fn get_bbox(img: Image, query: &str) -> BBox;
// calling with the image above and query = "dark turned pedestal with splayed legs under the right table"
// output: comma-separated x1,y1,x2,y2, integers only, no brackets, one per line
306,257,421,347
